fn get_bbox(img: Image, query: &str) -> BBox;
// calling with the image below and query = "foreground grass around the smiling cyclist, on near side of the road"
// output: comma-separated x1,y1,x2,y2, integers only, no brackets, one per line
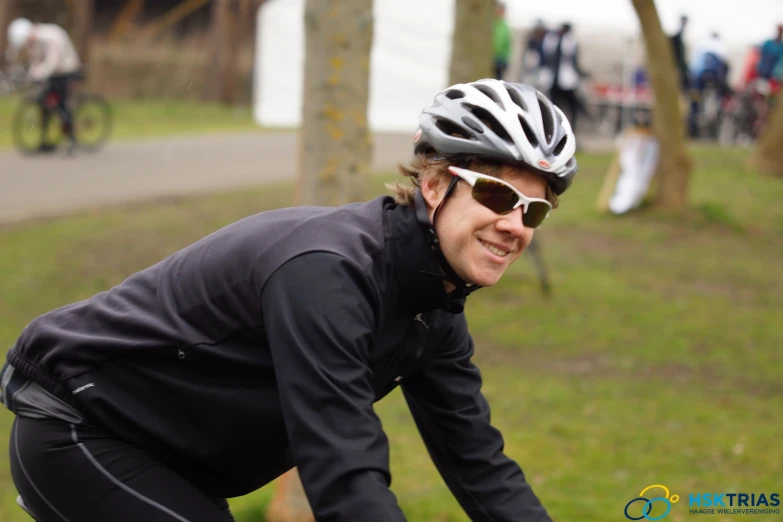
0,144,783,522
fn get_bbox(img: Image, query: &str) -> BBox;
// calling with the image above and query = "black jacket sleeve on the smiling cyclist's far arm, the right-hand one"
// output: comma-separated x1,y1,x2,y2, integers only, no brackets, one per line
402,315,551,522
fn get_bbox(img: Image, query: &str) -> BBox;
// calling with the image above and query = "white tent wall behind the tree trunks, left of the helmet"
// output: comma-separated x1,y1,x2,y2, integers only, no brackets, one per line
253,0,454,135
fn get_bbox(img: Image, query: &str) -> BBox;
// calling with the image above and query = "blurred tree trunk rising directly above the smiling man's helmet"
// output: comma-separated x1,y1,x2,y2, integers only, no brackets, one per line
449,0,495,85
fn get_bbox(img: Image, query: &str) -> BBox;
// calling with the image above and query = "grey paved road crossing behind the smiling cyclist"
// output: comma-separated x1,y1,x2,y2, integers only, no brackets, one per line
0,132,612,223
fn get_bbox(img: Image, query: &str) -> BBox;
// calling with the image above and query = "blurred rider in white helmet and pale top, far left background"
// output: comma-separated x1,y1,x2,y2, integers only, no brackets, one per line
8,18,81,151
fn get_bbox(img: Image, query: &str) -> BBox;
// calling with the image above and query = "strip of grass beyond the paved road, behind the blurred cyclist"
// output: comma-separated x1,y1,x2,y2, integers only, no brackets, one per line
0,96,276,150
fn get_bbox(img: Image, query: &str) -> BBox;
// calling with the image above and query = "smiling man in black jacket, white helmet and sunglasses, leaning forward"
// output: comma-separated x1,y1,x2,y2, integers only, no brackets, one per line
0,79,577,522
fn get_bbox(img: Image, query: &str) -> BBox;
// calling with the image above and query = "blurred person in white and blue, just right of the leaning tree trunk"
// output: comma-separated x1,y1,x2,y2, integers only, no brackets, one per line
688,32,731,137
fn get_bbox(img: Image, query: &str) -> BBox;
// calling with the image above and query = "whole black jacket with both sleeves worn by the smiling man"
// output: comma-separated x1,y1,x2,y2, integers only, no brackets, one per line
8,197,549,522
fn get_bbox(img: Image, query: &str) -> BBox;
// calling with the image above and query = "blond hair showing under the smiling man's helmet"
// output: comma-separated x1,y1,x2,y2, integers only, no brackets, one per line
386,154,558,208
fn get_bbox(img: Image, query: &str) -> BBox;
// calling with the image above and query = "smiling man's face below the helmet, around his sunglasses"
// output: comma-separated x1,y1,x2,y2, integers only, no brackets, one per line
422,166,546,286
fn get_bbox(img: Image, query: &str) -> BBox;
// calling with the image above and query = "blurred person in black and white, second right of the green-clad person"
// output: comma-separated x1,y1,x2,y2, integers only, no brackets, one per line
539,23,589,131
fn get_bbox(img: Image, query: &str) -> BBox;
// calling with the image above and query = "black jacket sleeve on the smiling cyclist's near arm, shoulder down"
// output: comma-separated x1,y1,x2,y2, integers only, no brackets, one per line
261,253,405,522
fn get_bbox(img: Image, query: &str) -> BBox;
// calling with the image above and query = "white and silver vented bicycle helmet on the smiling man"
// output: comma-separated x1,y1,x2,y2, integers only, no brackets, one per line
414,79,577,195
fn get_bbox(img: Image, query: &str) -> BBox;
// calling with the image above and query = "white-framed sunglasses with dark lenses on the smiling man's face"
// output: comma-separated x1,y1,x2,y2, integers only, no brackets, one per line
449,167,552,228
